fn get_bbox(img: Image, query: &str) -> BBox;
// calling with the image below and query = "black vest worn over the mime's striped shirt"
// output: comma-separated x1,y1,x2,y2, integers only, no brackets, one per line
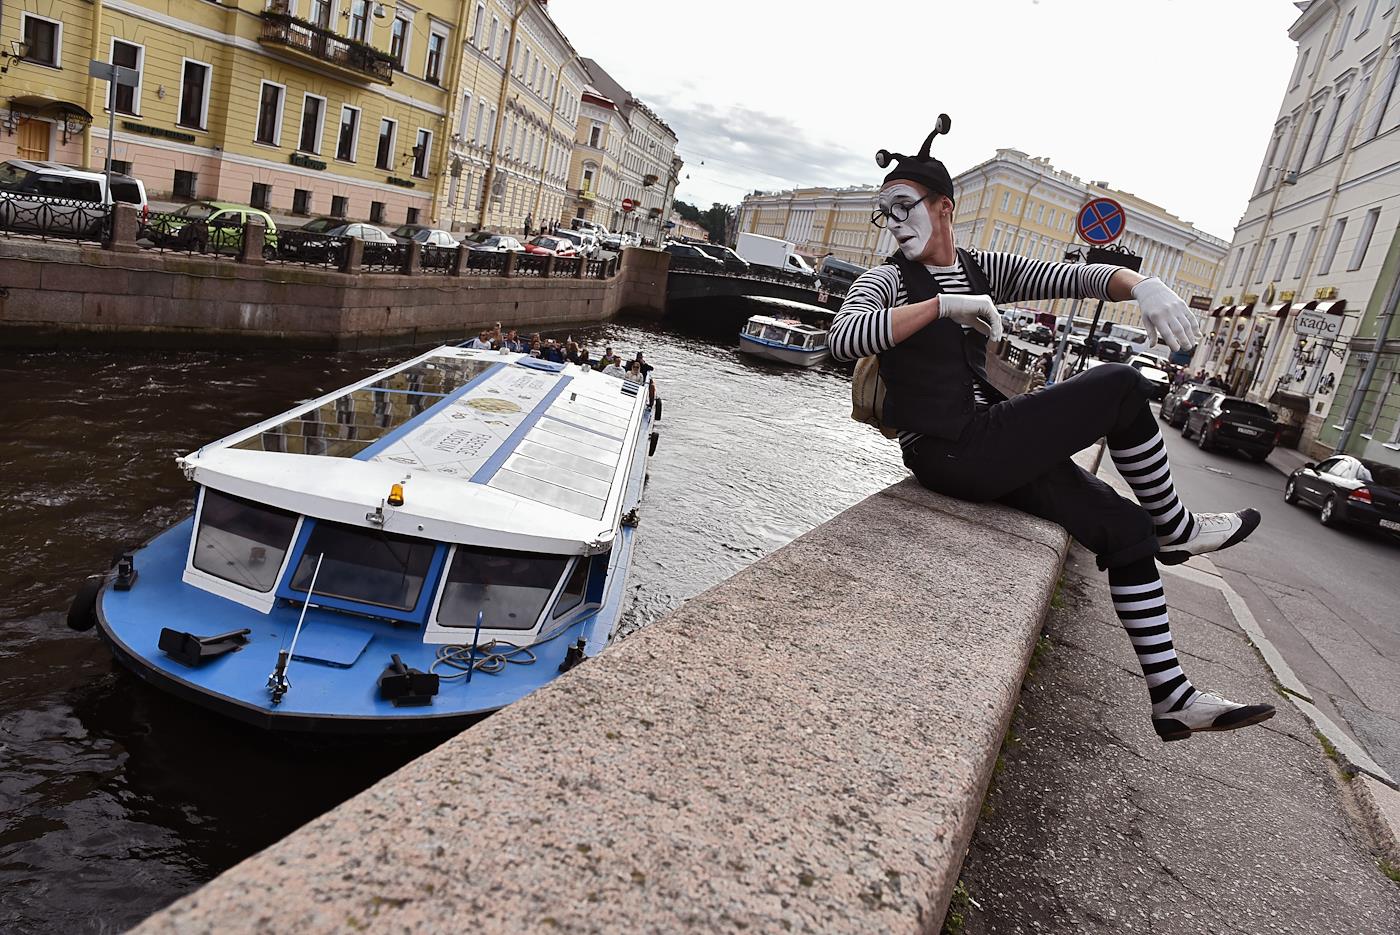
879,248,1005,440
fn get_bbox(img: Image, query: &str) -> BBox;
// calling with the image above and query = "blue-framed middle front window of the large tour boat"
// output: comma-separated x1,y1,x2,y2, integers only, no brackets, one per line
291,522,437,610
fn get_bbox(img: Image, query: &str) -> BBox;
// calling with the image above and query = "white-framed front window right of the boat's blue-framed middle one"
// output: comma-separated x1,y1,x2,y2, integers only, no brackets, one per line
437,546,568,630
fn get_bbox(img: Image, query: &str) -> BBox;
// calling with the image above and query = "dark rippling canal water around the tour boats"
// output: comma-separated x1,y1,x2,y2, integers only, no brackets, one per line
0,305,904,934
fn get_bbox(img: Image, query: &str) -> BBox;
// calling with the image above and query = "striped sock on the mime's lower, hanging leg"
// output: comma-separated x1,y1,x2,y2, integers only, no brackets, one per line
1109,558,1196,715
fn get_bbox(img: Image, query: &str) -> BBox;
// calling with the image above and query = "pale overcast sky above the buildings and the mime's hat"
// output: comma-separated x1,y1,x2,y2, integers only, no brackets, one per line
549,0,1298,241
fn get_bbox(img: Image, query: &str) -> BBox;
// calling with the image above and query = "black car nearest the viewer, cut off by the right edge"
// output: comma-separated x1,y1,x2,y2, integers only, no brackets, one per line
1284,455,1400,535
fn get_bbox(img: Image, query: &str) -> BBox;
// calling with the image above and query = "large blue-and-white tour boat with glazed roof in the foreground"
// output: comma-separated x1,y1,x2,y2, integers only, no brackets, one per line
69,347,661,733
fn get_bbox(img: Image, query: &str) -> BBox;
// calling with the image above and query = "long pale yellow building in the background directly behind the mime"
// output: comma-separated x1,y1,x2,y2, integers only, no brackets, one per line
736,150,1226,325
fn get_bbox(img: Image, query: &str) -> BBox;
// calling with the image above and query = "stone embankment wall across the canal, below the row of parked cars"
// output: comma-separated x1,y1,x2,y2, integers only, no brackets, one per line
0,229,669,349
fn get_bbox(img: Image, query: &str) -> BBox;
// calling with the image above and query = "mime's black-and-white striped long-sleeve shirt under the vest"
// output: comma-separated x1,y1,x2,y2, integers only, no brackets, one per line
826,251,1120,448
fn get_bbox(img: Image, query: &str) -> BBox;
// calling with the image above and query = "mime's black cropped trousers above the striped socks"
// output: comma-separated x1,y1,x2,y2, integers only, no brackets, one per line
904,364,1158,568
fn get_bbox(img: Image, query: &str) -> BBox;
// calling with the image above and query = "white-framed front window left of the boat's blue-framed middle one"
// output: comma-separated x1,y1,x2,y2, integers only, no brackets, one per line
192,487,297,592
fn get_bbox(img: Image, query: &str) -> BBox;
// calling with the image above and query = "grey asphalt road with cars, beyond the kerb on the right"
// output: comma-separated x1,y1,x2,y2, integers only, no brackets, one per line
1162,405,1400,777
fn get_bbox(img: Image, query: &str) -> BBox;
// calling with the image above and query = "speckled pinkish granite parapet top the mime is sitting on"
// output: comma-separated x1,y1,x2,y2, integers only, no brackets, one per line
137,447,1096,935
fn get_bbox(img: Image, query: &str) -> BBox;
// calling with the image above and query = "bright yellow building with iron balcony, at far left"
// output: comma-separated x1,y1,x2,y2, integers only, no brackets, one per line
0,0,470,224
